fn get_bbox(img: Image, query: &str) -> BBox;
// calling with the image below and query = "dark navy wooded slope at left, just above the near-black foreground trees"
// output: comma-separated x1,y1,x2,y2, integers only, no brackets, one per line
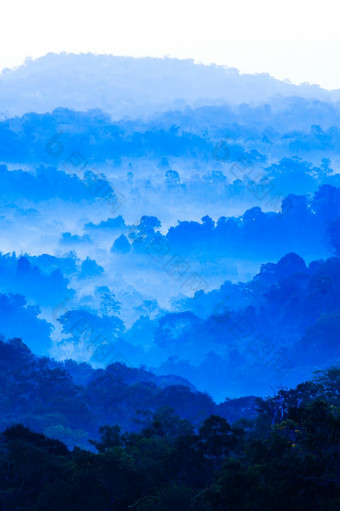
0,339,256,446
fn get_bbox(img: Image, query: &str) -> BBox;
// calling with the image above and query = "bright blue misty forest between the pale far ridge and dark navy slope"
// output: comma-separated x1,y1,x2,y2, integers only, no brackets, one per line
0,98,340,401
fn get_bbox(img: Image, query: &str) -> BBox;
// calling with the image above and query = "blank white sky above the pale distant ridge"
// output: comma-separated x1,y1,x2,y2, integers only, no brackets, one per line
0,0,340,88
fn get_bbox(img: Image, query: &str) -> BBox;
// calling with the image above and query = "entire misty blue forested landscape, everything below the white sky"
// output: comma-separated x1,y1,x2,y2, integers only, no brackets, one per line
0,55,340,511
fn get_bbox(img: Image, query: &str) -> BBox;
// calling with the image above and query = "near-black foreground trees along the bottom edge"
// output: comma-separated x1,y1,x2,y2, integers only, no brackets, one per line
0,368,340,511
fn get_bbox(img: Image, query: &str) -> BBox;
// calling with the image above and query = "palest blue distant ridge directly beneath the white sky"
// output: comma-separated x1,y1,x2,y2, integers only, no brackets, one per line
0,53,340,119
